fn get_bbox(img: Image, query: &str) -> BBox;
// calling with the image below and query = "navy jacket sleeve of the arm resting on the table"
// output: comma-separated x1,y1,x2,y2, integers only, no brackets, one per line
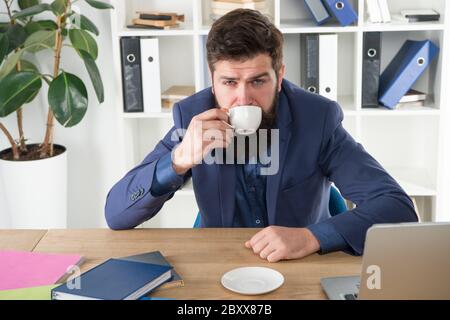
319,102,418,255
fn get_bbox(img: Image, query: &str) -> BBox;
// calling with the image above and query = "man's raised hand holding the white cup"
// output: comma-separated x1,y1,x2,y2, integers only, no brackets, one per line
172,108,233,174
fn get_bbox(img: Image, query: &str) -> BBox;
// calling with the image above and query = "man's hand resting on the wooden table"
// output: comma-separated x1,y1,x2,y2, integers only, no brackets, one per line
245,226,320,262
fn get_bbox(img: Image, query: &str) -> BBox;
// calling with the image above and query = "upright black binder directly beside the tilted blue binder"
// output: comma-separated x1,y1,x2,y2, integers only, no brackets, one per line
362,32,381,108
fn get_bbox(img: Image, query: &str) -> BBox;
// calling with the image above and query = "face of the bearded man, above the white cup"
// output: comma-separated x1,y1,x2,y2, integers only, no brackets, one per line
212,54,285,114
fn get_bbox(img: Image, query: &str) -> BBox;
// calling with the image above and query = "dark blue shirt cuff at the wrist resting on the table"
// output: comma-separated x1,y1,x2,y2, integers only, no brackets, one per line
307,222,349,254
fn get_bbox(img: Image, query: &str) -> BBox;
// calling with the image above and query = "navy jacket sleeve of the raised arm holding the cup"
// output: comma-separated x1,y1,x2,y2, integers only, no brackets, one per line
105,104,191,230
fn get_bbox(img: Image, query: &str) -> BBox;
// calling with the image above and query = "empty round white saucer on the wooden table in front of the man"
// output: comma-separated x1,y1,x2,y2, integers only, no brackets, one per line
222,267,284,295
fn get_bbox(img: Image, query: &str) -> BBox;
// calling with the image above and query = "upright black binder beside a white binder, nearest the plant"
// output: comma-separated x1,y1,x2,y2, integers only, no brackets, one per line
120,37,144,112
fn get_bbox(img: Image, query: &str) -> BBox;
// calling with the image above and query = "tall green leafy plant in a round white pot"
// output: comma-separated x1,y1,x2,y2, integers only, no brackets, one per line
0,0,113,228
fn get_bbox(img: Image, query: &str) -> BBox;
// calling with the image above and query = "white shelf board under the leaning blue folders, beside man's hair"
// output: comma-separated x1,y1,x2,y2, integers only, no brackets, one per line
279,19,358,34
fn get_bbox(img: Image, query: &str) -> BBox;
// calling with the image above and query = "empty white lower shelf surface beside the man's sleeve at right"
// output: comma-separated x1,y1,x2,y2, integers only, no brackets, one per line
386,167,437,197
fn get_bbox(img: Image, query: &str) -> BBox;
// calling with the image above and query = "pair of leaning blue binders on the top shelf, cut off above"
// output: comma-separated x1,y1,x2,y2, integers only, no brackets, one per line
304,0,358,26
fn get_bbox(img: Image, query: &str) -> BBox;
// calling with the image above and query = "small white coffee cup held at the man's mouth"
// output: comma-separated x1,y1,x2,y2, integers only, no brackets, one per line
228,106,262,135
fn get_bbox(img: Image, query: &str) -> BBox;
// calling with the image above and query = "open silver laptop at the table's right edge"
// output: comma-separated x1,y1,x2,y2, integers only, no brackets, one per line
321,223,450,300
